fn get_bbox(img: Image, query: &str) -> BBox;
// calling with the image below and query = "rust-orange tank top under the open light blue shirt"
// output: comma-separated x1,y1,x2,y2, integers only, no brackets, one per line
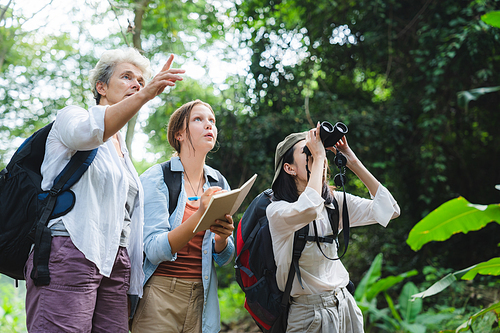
153,203,205,279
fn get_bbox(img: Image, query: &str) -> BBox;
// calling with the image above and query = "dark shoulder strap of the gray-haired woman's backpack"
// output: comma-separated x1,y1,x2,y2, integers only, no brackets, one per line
30,148,98,286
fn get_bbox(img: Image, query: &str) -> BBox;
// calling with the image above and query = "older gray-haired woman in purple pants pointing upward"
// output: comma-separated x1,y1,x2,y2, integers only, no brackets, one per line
25,48,184,332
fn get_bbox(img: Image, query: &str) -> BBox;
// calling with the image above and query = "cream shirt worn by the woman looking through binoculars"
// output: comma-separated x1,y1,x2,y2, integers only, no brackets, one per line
266,185,400,297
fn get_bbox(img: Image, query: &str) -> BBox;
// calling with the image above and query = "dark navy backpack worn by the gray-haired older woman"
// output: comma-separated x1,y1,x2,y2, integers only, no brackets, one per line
0,123,97,286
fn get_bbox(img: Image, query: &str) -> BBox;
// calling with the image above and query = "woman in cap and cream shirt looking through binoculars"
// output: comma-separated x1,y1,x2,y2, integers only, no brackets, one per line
266,123,400,333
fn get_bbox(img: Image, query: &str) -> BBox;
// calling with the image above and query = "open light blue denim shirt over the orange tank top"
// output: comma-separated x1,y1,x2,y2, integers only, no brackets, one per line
140,157,234,333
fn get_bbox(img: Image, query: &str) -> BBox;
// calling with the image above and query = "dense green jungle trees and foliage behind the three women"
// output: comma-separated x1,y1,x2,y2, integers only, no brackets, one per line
0,0,500,332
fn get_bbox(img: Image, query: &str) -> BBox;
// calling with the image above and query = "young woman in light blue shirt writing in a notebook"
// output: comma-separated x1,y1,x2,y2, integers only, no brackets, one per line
131,100,234,333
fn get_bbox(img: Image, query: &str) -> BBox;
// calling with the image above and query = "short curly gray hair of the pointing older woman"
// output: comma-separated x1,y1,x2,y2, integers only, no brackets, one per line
89,47,153,104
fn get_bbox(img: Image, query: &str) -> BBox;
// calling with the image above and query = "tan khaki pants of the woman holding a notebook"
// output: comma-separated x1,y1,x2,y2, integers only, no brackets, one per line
131,275,203,333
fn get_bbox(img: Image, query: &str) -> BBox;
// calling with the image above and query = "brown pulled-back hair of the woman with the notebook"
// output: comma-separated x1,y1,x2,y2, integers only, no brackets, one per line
167,99,215,153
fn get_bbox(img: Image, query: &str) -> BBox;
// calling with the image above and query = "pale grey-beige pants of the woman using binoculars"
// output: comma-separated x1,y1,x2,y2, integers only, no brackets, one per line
286,288,364,333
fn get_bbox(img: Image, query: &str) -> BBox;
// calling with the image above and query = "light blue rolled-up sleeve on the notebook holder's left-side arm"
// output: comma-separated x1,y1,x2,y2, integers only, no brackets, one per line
140,164,176,265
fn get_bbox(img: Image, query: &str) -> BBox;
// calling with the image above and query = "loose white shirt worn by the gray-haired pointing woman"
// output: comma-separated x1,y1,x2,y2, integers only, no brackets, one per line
41,106,144,296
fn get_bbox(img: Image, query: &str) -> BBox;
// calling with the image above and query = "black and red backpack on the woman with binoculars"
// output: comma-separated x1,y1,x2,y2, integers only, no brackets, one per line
235,189,354,333
